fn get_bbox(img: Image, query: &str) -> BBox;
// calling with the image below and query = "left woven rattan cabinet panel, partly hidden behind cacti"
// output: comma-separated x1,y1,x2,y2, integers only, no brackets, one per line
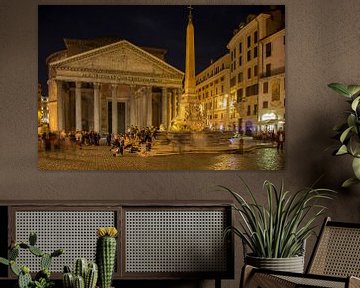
15,211,115,272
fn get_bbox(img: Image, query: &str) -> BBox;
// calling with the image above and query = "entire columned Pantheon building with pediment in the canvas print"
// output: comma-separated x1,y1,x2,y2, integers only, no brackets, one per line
47,39,184,133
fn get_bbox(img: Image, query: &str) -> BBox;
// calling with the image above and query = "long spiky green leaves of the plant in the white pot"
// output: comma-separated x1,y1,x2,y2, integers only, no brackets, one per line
220,179,335,258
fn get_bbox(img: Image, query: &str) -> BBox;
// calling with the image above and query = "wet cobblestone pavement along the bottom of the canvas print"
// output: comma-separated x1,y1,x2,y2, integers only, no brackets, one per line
38,146,285,170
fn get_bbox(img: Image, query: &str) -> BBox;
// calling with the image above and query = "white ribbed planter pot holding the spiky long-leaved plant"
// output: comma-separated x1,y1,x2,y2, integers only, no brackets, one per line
245,255,304,273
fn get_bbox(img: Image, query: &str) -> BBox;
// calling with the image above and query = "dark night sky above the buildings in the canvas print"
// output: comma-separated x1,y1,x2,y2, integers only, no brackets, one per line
38,5,282,95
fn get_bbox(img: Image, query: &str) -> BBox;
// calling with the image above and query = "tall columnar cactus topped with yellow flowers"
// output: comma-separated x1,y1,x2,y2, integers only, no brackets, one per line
96,227,118,288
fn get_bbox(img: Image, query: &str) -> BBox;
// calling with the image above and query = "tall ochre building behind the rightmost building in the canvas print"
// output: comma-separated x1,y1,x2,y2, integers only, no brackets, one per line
227,10,284,134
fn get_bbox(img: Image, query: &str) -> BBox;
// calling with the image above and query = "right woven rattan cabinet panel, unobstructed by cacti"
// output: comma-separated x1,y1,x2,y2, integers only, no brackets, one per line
125,210,227,273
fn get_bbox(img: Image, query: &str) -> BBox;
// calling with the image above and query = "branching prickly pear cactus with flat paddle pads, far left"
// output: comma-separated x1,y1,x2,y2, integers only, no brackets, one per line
0,233,64,288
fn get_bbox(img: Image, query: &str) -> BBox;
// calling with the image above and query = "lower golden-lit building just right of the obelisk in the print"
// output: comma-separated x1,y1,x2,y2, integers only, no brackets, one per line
196,54,232,130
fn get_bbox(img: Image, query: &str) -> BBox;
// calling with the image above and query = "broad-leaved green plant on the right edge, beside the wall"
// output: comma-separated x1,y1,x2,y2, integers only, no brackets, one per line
328,83,360,187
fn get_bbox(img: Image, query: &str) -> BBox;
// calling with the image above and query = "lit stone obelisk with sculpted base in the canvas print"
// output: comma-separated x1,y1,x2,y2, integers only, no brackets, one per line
177,6,204,131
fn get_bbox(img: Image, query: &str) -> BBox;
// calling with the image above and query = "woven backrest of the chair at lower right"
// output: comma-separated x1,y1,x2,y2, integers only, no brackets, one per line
307,218,360,277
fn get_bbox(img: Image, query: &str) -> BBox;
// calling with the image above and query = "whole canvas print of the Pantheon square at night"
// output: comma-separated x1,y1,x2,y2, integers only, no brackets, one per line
38,5,286,171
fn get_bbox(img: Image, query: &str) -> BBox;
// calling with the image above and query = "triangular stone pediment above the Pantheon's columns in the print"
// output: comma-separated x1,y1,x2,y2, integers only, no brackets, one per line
50,40,184,78
